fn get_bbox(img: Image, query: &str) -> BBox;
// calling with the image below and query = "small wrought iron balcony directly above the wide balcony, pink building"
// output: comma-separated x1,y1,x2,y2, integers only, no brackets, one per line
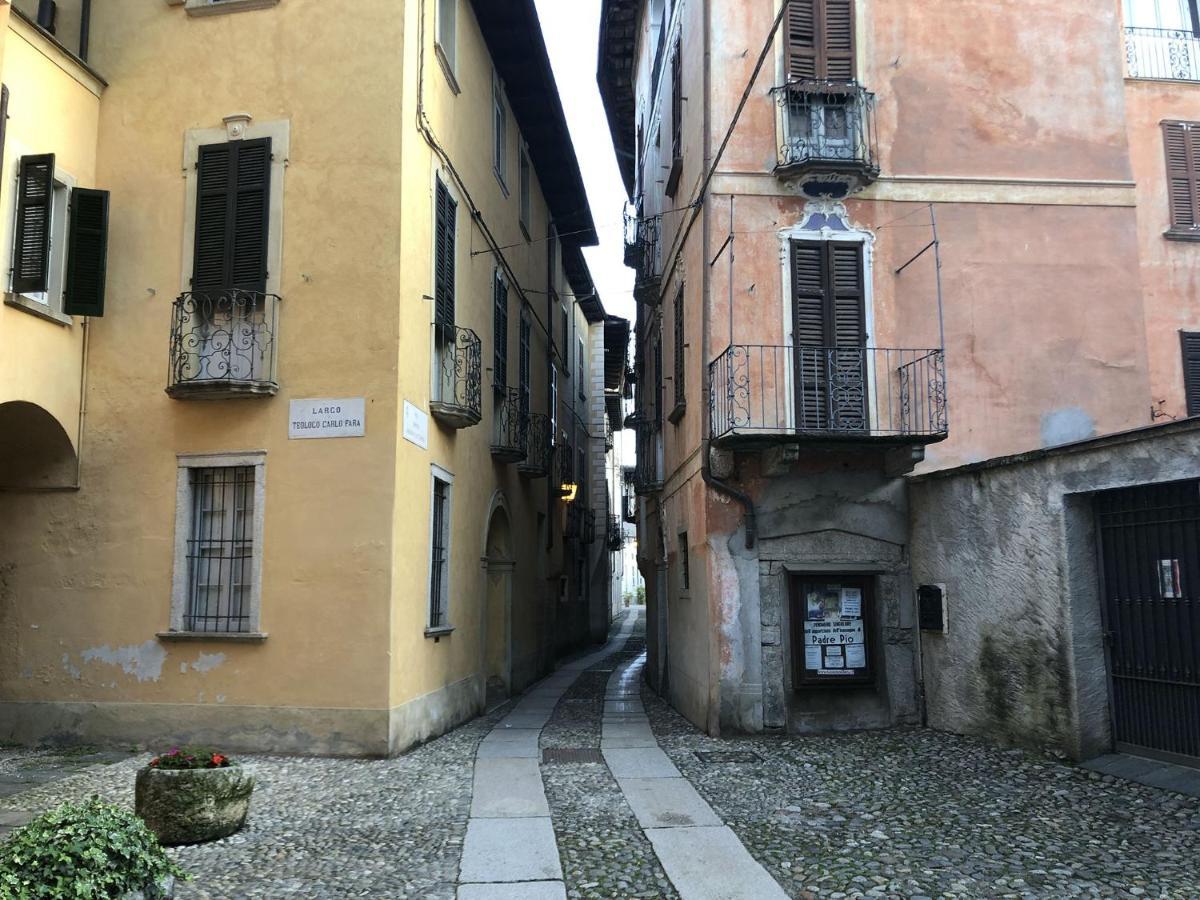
772,80,880,198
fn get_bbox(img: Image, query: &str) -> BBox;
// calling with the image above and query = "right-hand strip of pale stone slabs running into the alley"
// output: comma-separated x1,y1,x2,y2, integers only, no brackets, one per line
600,653,787,900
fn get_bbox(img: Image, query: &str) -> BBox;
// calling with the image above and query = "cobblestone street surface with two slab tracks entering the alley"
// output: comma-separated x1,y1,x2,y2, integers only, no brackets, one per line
0,609,1200,900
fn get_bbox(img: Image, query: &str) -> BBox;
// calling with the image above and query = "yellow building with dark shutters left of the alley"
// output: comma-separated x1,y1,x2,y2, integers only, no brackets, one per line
0,0,633,754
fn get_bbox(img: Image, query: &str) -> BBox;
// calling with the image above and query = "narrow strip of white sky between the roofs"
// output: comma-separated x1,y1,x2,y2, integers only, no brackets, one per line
535,0,634,322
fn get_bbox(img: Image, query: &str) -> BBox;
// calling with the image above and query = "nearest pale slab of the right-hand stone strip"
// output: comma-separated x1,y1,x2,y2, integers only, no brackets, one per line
646,826,787,900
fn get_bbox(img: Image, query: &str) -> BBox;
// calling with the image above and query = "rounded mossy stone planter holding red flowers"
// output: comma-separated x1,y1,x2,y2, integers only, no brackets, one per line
134,766,254,846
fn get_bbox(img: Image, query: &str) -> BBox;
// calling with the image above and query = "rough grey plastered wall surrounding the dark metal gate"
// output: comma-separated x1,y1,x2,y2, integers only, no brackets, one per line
910,419,1200,758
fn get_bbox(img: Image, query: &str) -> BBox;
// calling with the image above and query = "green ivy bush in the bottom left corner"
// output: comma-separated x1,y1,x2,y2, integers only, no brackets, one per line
0,797,187,900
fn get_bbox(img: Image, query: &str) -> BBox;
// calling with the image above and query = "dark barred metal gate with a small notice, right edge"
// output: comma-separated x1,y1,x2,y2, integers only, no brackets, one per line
1096,480,1200,766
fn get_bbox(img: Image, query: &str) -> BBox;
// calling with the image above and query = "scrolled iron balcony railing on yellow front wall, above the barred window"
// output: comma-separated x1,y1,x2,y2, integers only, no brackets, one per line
167,289,280,400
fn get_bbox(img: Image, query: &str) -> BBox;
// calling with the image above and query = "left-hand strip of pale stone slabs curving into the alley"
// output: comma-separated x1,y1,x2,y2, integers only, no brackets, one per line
457,613,643,900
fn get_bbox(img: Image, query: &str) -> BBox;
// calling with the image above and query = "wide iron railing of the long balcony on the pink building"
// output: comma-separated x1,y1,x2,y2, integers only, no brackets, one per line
710,344,948,444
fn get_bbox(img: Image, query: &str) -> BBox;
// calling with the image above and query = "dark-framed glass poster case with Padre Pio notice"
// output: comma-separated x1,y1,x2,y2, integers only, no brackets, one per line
792,576,872,686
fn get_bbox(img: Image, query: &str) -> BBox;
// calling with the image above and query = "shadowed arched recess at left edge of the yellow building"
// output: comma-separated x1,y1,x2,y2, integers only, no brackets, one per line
0,401,76,488
